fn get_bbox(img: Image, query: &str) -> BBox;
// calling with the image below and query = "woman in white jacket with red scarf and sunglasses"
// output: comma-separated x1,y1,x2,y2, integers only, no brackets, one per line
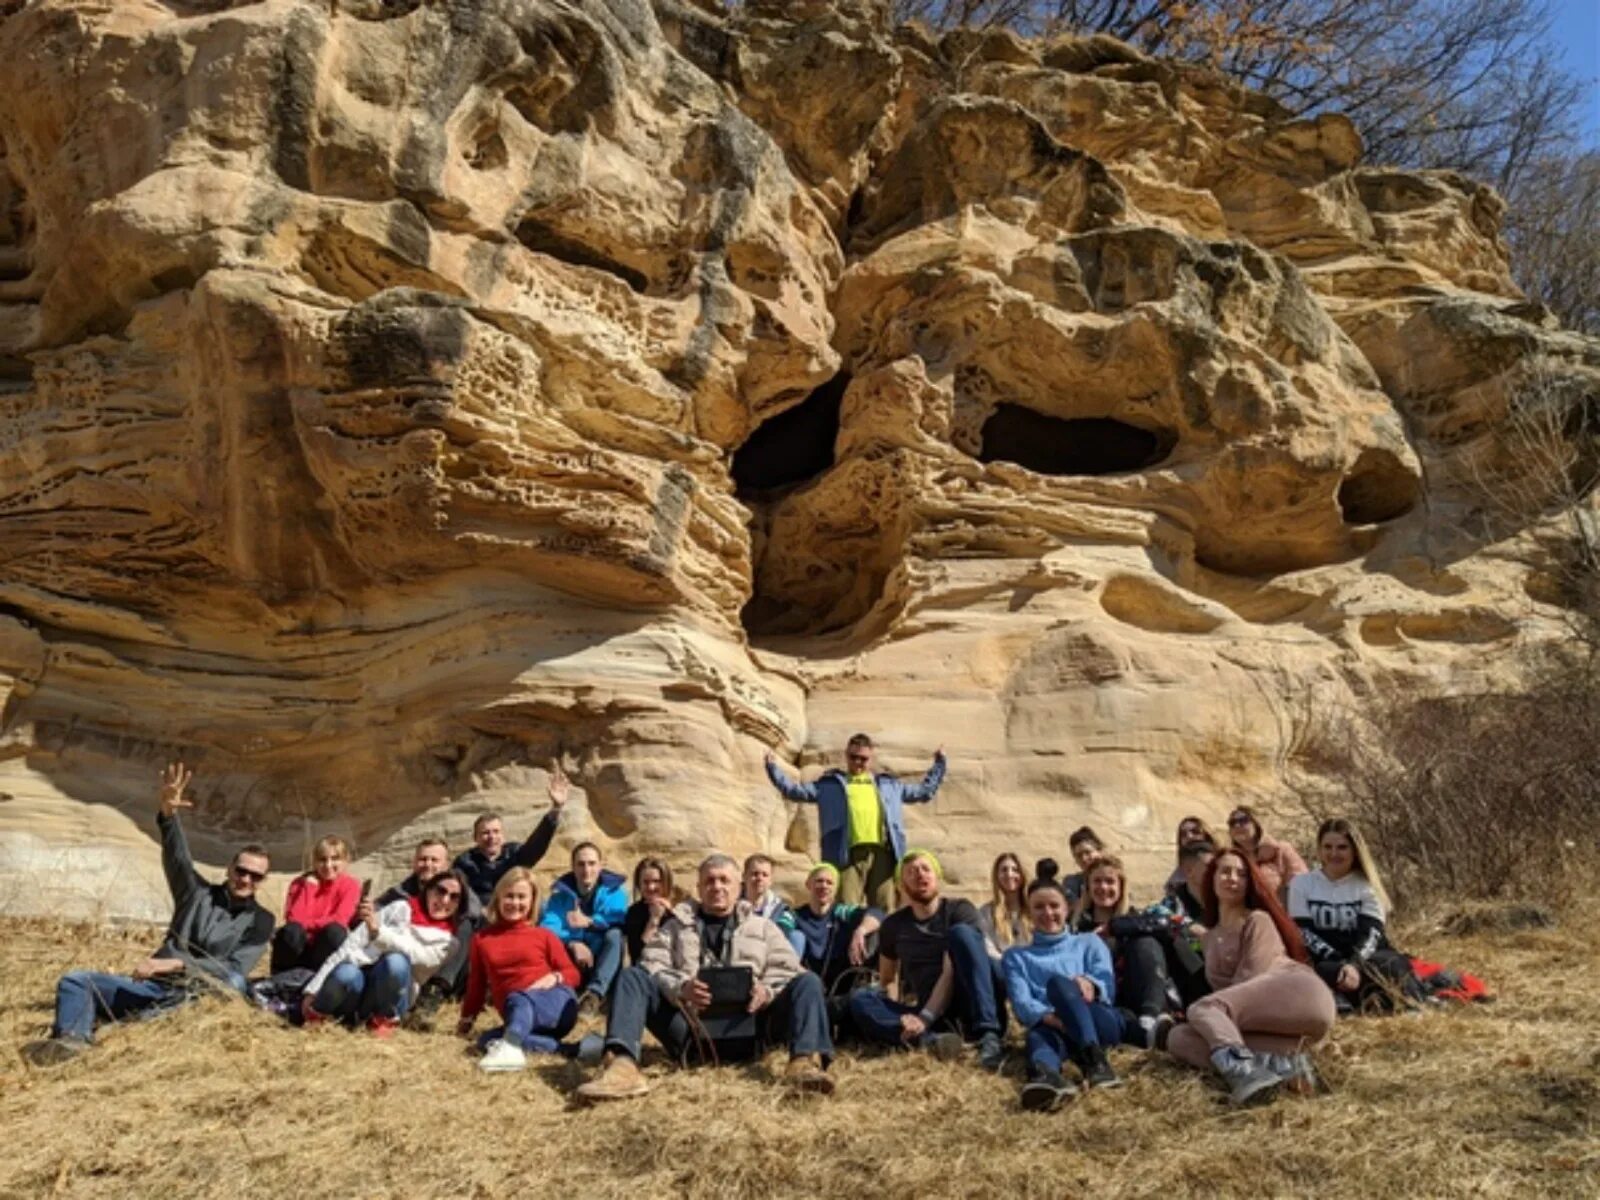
301,870,470,1037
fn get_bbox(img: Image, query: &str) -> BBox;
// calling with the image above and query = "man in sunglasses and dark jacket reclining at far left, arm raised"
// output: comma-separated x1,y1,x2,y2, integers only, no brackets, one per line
27,763,272,1066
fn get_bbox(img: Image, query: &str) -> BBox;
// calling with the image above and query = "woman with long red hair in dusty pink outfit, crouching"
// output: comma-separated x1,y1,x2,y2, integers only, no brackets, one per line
1166,848,1334,1104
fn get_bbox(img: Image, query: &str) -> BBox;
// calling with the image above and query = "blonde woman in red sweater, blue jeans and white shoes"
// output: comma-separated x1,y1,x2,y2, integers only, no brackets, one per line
458,867,579,1070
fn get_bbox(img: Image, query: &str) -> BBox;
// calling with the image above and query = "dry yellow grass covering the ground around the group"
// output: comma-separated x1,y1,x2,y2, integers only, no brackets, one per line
0,920,1600,1200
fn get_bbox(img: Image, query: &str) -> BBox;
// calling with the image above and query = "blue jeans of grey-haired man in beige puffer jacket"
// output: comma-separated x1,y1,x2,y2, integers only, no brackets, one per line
605,966,834,1062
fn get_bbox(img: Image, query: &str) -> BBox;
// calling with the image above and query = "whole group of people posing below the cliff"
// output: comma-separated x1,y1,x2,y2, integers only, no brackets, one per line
30,734,1478,1110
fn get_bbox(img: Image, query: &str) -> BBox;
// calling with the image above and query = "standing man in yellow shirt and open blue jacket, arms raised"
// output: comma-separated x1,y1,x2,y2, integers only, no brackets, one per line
766,733,944,912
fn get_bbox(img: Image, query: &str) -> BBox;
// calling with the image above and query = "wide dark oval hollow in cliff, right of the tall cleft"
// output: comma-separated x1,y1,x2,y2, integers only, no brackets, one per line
978,403,1178,475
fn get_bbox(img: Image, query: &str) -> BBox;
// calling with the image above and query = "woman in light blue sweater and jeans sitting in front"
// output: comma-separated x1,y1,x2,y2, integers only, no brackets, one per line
1002,872,1123,1112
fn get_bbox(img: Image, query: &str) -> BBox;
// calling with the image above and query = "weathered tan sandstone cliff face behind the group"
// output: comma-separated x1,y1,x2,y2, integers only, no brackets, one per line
0,0,1600,912
